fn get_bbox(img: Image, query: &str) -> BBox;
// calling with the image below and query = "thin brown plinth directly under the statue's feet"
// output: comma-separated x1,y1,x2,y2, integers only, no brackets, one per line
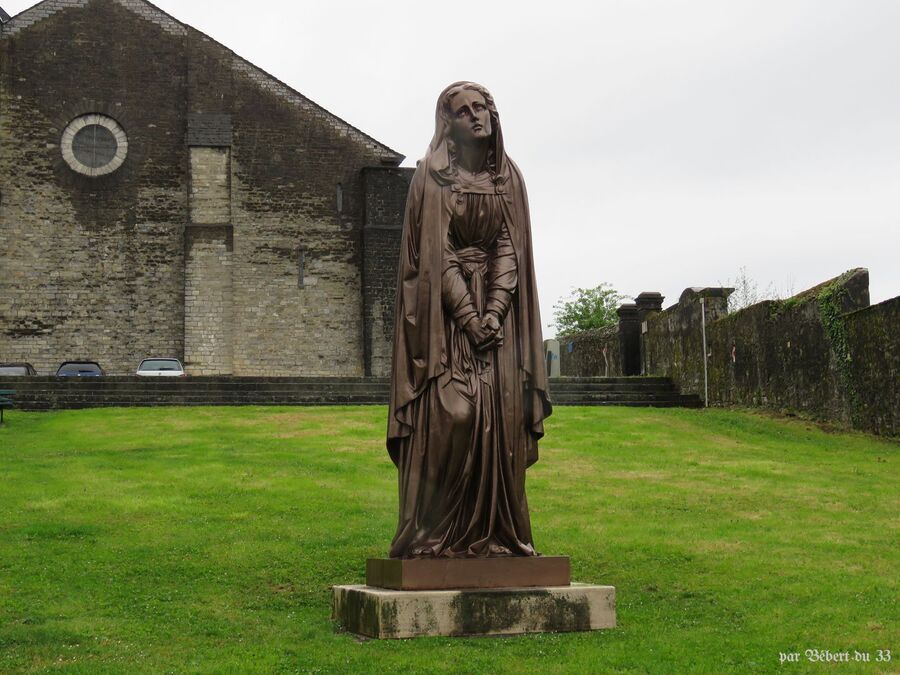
366,556,571,591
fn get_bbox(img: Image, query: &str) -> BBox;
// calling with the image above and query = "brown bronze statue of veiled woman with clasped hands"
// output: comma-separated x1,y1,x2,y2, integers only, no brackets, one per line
387,82,550,558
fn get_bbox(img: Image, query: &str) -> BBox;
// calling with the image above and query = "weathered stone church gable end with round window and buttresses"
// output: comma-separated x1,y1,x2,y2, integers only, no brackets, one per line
0,0,411,376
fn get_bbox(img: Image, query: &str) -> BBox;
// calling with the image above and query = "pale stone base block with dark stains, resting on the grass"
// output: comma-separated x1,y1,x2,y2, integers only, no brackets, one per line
332,584,616,638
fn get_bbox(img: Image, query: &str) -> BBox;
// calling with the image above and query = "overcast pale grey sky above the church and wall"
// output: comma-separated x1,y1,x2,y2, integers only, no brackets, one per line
0,0,900,335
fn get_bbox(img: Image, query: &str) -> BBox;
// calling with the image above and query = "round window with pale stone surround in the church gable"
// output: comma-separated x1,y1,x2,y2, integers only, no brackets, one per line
61,115,128,176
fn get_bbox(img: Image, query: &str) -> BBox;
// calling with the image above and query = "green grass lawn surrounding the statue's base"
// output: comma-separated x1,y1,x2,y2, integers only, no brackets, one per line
0,407,900,673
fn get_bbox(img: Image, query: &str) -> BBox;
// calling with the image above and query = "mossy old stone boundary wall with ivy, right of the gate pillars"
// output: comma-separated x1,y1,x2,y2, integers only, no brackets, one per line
644,270,900,434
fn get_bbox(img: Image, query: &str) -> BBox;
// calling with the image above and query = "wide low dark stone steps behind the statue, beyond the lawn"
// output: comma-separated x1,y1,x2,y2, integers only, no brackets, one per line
0,376,701,411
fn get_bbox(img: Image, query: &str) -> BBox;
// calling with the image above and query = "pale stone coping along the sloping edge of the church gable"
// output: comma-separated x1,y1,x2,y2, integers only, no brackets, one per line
0,0,405,164
